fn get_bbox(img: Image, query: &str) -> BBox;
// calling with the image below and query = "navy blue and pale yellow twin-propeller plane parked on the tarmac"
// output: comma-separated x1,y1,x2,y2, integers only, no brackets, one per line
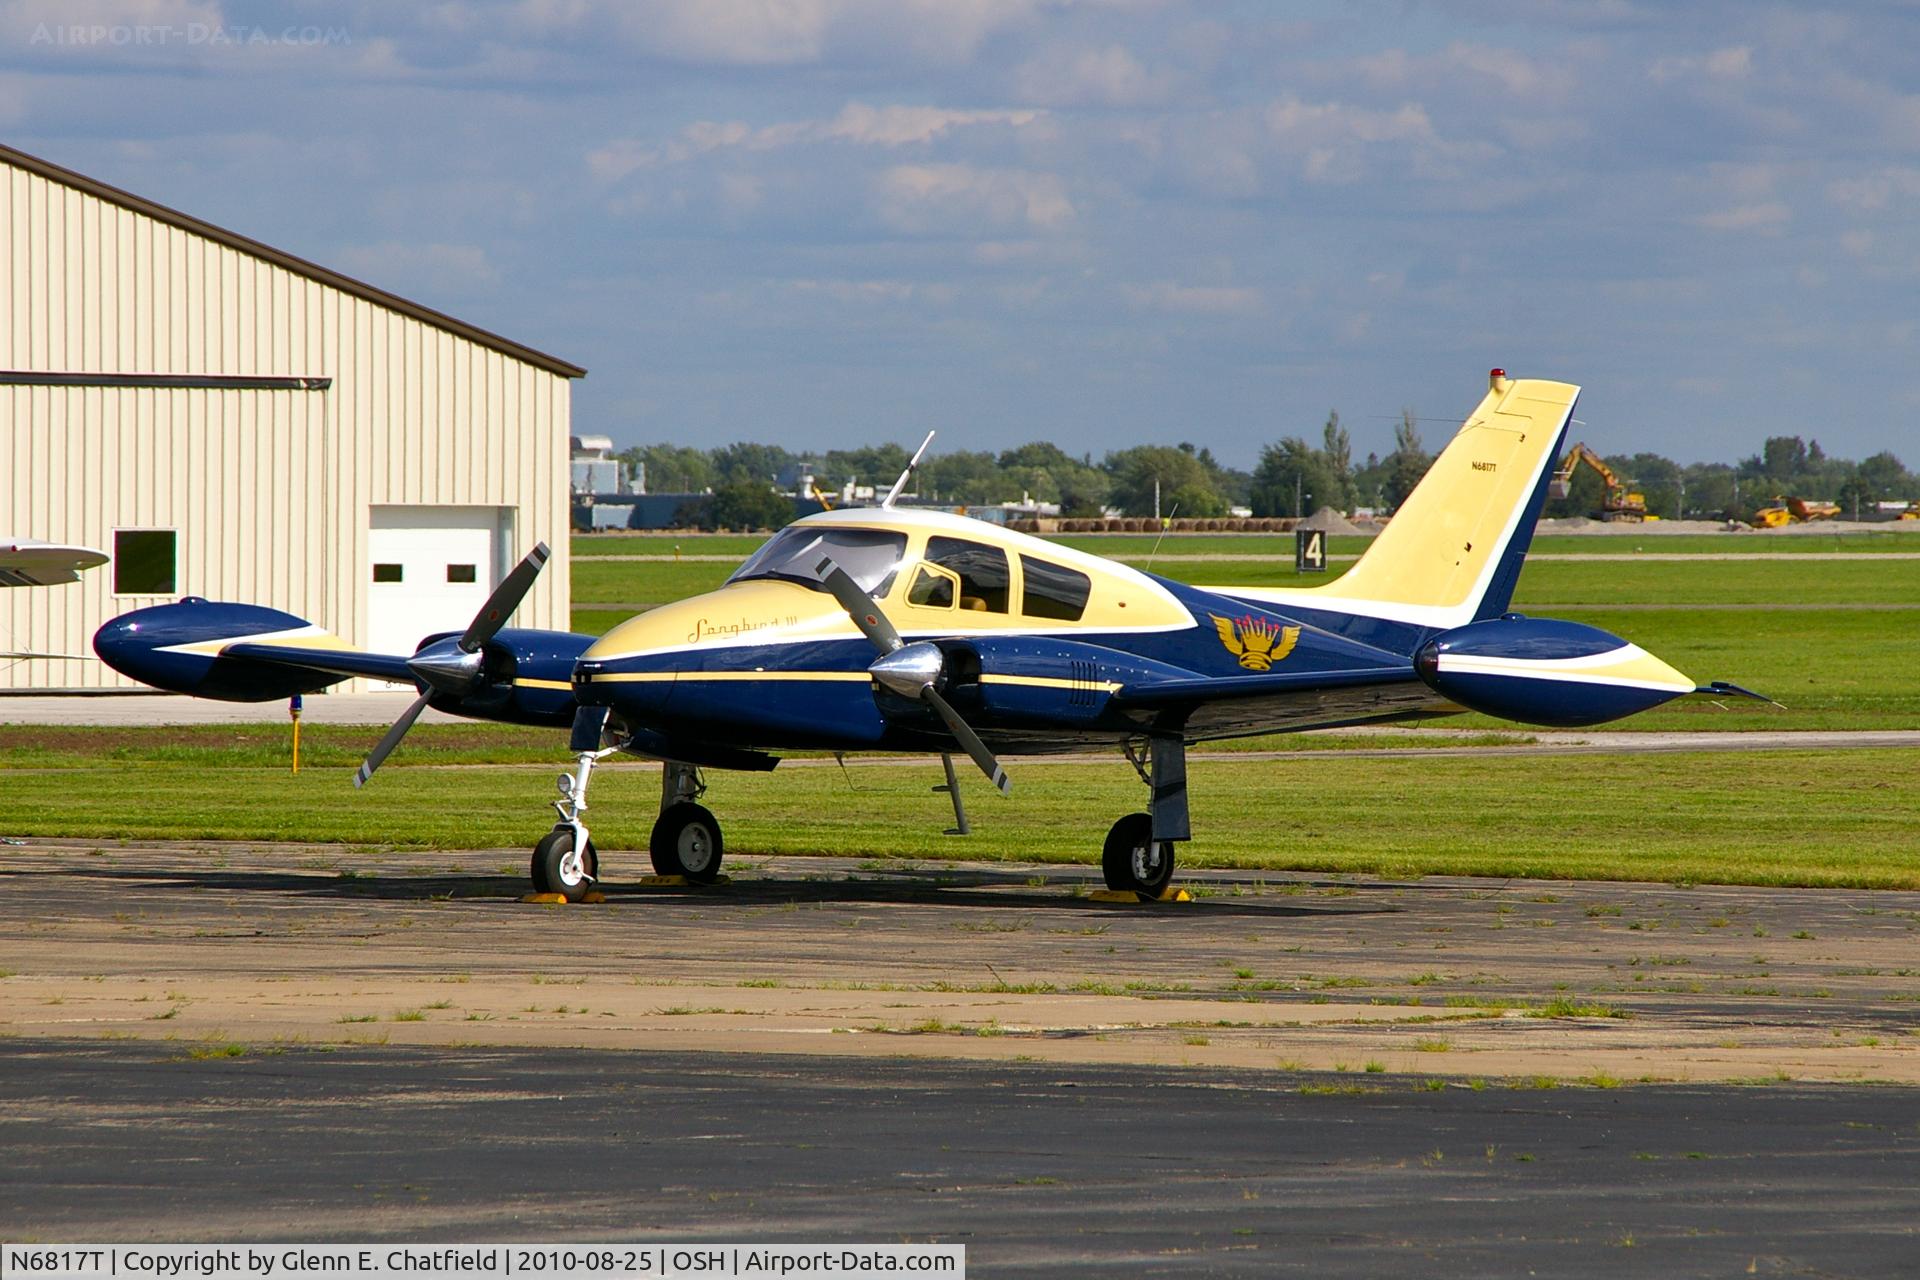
94,368,1759,898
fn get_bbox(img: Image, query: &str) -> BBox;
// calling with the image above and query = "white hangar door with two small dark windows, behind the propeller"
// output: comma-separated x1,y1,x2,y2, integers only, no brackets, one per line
367,507,511,675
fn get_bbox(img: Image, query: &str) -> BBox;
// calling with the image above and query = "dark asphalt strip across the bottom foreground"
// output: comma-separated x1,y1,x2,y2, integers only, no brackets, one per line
0,1040,1920,1278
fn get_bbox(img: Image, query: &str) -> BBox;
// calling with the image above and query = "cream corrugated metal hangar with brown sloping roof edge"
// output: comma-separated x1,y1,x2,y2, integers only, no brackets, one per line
0,146,586,693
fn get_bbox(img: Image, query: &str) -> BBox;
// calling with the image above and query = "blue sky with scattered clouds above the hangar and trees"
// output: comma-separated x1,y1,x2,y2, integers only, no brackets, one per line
0,0,1920,466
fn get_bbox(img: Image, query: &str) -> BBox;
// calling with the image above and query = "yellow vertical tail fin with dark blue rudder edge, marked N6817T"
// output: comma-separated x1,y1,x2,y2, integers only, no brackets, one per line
1288,368,1580,628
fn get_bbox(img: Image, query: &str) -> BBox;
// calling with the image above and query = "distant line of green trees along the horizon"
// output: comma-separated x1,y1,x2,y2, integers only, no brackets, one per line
620,422,1920,528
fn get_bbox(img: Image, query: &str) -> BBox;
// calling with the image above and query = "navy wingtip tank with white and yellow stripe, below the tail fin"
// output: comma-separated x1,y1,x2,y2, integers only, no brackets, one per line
1413,614,1695,727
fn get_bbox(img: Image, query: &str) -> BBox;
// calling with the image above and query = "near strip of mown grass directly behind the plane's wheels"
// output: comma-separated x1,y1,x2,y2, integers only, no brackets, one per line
4,744,1920,889
